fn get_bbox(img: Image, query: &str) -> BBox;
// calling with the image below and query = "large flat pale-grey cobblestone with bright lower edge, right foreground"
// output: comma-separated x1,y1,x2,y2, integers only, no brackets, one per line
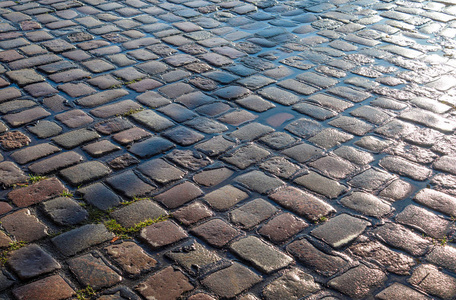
311,214,370,248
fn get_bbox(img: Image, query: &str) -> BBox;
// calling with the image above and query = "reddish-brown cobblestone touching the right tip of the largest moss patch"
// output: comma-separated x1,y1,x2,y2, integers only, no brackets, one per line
140,221,188,249
